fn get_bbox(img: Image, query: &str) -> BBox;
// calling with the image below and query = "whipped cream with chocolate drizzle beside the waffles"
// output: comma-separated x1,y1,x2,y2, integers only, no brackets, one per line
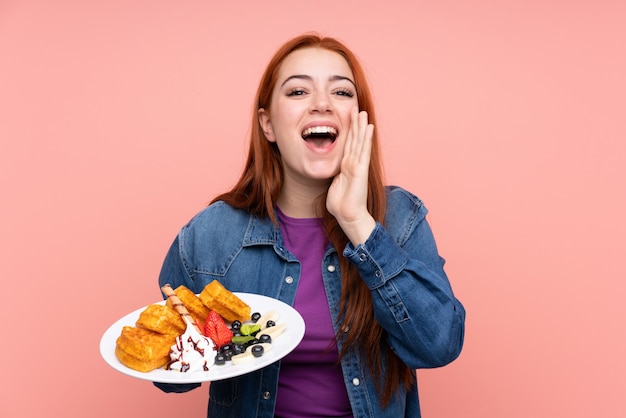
167,324,217,372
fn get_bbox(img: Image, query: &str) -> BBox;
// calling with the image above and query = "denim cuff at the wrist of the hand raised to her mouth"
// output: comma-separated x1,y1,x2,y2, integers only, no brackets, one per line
343,222,408,290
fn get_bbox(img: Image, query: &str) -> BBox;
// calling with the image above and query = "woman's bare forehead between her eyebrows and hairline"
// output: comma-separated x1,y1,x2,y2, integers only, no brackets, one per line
278,48,354,84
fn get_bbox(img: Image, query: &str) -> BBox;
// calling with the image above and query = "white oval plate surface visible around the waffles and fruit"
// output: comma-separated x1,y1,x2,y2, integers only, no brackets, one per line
100,293,304,383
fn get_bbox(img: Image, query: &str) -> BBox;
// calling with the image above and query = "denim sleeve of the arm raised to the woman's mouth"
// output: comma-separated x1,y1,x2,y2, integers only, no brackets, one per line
344,218,465,369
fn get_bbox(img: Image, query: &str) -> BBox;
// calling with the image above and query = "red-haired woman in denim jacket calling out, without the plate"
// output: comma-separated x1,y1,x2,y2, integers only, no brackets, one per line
157,35,465,417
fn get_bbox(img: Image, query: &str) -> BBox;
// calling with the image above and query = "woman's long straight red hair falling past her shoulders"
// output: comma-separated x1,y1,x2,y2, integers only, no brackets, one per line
213,34,415,405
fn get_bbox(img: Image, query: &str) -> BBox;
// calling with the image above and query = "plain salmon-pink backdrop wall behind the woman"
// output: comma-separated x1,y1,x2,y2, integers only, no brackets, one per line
0,0,626,418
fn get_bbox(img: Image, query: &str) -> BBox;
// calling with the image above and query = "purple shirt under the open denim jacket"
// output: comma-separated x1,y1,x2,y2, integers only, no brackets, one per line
275,210,352,418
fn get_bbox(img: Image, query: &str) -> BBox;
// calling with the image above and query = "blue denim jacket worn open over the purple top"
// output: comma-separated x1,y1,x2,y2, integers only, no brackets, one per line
156,187,465,417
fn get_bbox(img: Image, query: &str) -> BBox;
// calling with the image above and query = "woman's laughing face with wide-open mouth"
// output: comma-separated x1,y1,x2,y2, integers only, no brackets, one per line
259,48,358,185
